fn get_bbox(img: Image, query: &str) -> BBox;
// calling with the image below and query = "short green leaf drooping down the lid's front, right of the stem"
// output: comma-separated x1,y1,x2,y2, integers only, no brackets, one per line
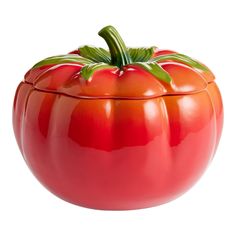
132,62,171,83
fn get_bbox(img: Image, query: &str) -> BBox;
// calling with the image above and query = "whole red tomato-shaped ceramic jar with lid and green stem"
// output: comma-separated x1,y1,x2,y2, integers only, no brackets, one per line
13,26,223,210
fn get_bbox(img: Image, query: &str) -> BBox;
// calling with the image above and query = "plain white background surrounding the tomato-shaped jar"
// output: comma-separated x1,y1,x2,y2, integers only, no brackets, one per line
0,0,236,236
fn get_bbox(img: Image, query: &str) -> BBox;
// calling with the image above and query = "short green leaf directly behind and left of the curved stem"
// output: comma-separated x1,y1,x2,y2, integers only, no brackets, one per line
79,46,111,64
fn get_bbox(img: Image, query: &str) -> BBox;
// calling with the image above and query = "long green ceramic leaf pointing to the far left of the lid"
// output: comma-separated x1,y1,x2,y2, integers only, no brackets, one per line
33,54,92,68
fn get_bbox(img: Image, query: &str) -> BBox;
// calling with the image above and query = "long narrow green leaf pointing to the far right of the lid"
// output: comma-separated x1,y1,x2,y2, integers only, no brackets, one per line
150,53,209,71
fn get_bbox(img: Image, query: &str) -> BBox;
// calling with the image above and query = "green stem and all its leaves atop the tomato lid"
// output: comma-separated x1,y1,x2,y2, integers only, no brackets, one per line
33,26,208,83
